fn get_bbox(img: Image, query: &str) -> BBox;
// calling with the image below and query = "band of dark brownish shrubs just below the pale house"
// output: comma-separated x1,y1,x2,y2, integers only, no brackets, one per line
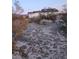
29,14,56,24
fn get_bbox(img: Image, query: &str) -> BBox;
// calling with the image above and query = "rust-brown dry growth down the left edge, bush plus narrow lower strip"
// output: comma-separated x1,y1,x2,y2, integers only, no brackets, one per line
12,14,29,53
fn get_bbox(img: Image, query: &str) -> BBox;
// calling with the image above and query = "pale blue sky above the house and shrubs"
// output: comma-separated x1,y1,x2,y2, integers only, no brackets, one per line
12,0,67,12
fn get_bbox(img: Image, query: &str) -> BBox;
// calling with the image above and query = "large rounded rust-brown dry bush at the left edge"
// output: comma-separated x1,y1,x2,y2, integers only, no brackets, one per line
12,15,29,36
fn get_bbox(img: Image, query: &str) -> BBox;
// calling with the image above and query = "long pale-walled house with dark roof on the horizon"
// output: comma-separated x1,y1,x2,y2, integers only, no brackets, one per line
28,8,58,18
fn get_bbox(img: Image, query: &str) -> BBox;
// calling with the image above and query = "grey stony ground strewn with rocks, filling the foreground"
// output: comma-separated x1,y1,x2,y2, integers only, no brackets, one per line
12,19,67,59
